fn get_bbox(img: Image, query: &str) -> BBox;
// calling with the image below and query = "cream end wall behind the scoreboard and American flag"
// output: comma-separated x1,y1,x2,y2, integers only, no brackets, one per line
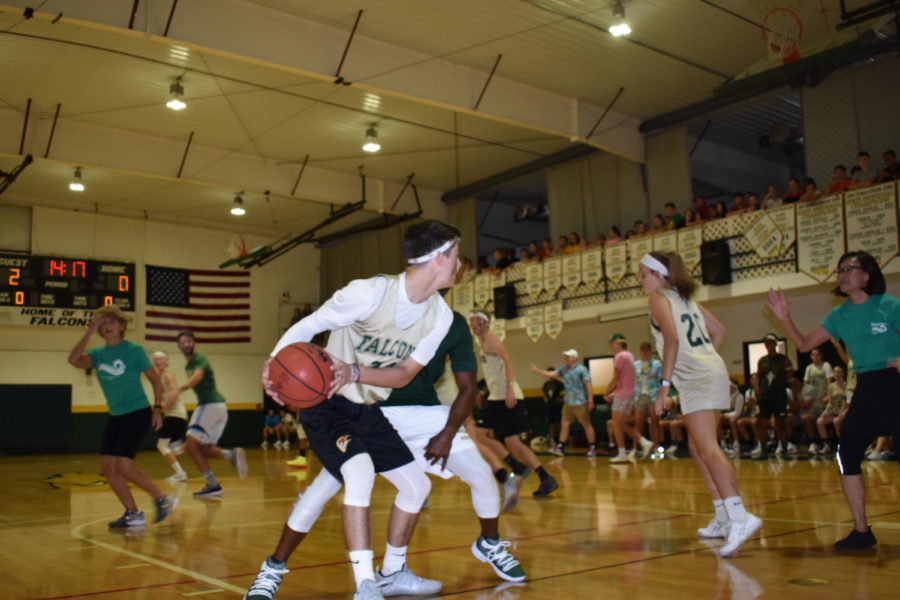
0,208,320,411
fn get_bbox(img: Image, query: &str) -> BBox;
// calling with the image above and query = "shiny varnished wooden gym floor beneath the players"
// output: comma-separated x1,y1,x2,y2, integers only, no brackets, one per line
0,449,900,600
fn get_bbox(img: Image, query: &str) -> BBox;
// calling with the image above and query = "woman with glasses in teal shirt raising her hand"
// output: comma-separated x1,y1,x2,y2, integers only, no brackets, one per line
766,252,900,550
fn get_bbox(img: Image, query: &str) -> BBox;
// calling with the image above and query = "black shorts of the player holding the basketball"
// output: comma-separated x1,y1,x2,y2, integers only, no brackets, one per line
303,396,413,481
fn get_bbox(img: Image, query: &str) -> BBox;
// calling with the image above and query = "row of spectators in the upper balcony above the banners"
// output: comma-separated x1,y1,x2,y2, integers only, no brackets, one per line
468,150,900,281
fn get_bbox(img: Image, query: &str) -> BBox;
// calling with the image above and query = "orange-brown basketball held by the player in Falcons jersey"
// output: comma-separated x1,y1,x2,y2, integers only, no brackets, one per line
269,342,334,408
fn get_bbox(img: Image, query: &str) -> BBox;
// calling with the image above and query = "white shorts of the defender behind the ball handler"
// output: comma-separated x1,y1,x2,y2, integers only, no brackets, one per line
381,405,475,479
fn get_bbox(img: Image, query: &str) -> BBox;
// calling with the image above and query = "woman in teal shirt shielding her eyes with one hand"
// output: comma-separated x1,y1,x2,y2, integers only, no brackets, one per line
69,306,175,528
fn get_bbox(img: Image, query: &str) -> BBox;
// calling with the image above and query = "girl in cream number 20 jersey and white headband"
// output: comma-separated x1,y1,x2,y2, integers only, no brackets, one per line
638,252,762,556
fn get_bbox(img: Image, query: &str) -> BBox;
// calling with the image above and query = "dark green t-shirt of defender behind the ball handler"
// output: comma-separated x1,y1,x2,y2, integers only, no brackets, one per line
381,311,478,406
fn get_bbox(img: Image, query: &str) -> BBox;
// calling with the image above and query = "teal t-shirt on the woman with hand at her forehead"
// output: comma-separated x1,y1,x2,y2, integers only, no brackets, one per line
87,340,153,416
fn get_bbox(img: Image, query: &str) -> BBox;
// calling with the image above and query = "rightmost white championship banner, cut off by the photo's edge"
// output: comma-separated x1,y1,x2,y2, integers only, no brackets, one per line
844,183,900,267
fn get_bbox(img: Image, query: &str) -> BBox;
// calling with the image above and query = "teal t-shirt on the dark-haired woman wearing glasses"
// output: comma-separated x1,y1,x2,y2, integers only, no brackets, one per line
822,294,900,373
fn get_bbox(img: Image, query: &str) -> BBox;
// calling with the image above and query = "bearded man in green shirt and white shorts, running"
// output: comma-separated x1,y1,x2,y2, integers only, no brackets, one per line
178,331,247,498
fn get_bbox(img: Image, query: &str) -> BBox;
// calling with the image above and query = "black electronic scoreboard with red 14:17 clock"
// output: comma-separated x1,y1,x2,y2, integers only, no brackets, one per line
0,254,134,311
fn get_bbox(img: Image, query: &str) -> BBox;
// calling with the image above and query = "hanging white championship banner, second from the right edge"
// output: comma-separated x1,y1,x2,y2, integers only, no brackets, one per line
797,196,844,282
